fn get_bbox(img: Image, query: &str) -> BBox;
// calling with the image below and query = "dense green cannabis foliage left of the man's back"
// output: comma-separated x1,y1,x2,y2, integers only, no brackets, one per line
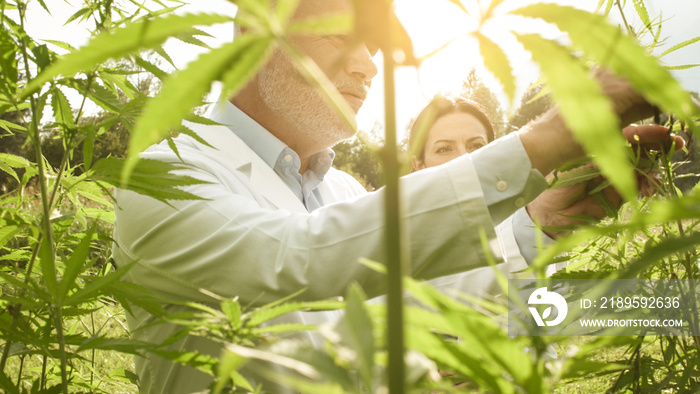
0,2,219,393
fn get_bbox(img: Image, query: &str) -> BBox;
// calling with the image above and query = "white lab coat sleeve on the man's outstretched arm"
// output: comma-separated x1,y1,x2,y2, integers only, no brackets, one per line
114,131,548,306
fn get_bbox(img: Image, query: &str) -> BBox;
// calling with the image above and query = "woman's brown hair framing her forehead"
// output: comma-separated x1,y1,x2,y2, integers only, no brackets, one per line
408,95,496,160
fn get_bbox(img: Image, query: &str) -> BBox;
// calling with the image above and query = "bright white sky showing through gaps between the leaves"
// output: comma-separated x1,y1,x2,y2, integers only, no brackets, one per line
27,0,700,135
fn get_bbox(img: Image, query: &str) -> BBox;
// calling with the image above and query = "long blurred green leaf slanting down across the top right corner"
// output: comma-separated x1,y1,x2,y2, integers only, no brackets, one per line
512,4,700,124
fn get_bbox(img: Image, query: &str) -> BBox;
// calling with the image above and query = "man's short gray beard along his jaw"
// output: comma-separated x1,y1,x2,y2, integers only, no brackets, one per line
258,51,355,145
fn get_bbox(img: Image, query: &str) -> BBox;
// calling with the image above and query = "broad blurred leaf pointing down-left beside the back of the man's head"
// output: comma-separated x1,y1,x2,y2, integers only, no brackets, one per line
123,35,274,180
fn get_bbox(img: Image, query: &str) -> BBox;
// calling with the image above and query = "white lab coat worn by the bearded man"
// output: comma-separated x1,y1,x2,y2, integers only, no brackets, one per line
114,124,540,393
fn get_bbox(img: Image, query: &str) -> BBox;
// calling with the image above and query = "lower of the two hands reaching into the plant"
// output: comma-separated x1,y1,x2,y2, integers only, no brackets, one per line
526,125,685,238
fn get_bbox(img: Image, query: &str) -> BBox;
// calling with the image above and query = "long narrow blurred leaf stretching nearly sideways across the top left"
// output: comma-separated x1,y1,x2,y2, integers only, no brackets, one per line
22,14,231,98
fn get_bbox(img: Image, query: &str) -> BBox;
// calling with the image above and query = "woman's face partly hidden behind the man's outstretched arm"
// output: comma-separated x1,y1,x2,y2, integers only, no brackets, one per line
412,113,488,171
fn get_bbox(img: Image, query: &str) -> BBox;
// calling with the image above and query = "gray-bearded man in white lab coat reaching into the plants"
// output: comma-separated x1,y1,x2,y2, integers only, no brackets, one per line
114,0,680,393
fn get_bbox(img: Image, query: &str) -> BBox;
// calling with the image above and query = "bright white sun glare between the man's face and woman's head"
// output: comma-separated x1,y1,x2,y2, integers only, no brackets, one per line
358,0,595,135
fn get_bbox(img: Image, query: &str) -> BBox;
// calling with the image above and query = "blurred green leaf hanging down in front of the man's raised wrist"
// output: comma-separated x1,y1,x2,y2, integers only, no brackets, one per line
516,34,637,201
